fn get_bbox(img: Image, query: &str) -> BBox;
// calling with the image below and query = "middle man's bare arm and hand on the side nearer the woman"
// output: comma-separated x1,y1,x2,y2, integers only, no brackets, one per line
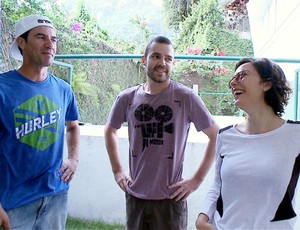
169,123,219,201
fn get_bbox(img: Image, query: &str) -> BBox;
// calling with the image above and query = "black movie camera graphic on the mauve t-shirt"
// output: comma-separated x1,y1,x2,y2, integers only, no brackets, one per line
134,104,174,150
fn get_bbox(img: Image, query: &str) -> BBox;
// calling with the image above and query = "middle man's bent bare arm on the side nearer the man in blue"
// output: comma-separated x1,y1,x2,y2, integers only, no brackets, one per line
104,124,132,192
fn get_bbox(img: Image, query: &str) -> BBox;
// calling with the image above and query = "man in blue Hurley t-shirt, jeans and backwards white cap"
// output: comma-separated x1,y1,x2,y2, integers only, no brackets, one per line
0,15,80,230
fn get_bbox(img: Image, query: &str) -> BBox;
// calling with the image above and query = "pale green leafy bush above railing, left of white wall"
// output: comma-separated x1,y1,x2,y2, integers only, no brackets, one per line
175,0,253,56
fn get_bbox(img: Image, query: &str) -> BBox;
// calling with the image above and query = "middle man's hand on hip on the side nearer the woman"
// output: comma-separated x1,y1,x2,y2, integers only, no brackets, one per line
169,179,200,201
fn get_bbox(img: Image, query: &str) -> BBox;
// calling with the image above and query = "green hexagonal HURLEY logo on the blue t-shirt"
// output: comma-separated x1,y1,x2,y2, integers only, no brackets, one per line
14,94,61,151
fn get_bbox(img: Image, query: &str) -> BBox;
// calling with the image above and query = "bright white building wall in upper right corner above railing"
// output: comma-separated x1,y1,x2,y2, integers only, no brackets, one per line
247,0,300,59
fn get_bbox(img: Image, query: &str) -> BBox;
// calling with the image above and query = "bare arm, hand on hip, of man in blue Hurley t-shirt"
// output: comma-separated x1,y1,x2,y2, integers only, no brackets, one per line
59,121,80,182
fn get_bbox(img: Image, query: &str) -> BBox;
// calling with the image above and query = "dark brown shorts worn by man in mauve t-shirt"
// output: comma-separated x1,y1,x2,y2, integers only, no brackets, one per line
126,193,188,230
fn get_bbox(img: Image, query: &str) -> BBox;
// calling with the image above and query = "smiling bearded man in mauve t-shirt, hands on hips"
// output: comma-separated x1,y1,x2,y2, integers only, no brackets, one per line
105,36,219,229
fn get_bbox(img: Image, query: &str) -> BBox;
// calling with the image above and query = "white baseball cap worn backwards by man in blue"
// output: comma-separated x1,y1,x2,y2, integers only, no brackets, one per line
10,15,55,60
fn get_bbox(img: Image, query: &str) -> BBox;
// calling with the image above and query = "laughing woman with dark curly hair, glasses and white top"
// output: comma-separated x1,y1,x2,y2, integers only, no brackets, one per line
196,58,300,229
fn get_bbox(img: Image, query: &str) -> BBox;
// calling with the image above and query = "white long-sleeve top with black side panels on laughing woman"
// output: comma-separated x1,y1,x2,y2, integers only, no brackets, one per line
201,121,300,229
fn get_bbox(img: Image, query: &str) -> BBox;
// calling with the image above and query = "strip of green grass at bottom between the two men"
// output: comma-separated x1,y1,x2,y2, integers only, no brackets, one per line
66,217,125,230
